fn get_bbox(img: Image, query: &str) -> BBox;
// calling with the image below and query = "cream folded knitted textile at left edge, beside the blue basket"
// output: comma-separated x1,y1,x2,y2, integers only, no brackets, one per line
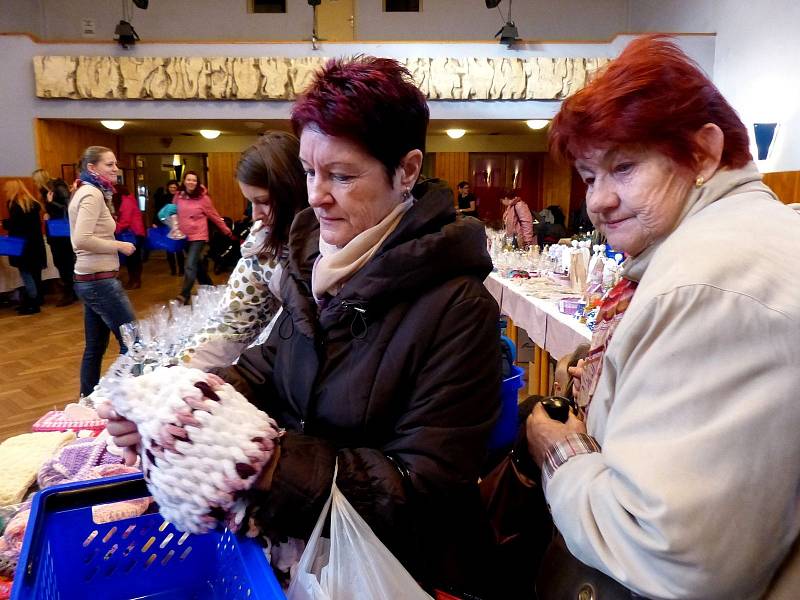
0,431,75,506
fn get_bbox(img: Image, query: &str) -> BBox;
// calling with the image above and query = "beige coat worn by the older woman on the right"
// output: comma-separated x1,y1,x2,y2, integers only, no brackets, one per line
547,164,800,600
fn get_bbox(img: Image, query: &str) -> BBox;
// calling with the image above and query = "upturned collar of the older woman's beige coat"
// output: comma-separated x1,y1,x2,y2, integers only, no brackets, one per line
623,162,777,281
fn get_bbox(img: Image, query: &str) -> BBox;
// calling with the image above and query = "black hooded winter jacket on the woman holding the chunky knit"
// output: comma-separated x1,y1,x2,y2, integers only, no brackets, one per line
223,180,500,589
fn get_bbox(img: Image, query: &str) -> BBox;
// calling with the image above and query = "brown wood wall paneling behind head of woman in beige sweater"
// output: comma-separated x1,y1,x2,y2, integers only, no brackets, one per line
34,119,119,183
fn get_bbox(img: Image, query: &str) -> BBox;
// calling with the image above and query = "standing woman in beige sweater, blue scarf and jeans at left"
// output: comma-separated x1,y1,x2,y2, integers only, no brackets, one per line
67,146,136,396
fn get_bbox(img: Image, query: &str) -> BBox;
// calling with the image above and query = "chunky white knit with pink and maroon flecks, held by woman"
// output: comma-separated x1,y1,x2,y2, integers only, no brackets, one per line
111,367,280,533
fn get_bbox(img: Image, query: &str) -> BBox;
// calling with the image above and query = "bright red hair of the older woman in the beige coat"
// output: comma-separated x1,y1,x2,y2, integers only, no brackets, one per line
549,34,752,170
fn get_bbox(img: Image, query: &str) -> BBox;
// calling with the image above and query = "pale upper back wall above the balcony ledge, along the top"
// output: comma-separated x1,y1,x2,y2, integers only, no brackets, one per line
0,0,628,41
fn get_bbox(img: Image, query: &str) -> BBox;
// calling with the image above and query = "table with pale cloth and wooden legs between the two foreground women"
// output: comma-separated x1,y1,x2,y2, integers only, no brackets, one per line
484,273,592,395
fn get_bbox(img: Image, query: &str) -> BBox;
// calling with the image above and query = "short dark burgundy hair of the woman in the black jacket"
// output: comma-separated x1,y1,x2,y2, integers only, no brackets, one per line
292,56,430,182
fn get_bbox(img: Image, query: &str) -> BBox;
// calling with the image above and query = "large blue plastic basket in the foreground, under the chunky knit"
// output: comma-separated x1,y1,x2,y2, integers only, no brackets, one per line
11,474,285,600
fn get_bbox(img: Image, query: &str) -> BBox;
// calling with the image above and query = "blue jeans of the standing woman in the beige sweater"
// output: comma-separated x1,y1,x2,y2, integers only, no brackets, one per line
75,277,136,396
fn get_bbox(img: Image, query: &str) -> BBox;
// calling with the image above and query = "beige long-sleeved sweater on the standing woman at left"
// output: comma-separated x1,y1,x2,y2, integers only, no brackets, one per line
68,185,119,274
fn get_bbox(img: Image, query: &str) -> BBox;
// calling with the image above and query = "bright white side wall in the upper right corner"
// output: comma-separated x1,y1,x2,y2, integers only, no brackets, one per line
630,0,800,172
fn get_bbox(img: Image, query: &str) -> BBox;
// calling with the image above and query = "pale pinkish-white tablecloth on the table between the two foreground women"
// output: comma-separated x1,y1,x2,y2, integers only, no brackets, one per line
483,273,592,359
